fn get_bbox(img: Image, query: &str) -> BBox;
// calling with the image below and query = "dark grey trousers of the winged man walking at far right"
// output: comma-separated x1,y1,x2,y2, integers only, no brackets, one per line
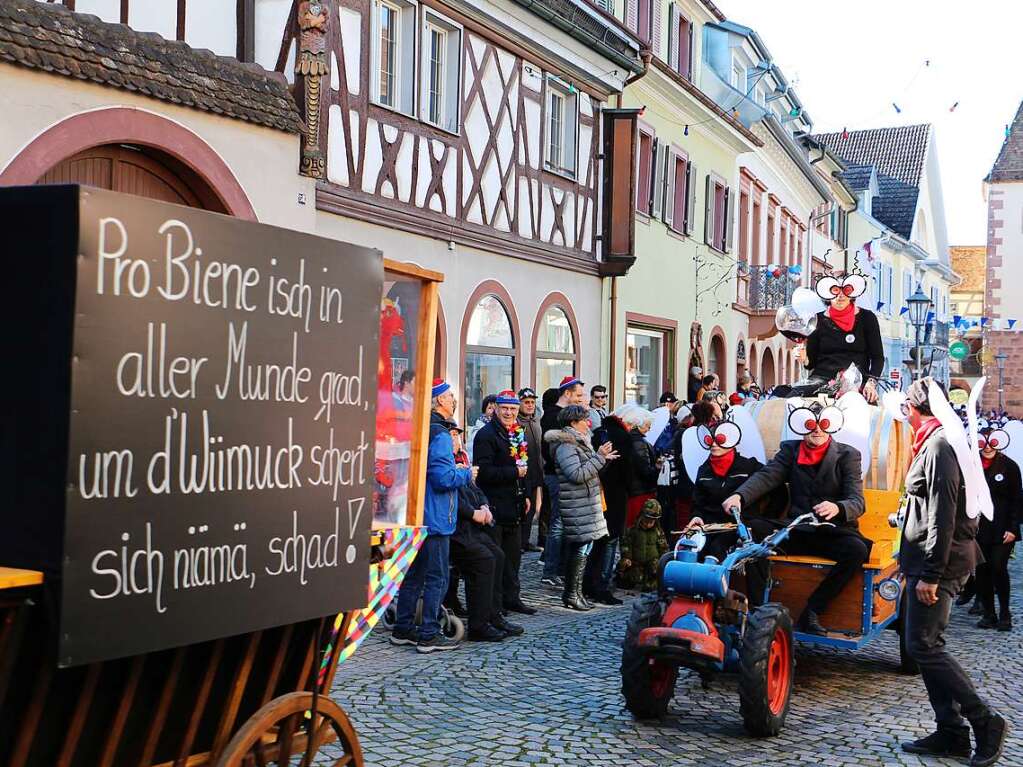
903,578,990,728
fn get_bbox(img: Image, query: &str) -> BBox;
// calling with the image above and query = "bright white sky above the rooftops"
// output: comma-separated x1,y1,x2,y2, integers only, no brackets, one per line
716,0,1023,244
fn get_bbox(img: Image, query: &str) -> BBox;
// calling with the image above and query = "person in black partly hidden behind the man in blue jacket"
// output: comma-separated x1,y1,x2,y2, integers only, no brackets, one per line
447,421,524,642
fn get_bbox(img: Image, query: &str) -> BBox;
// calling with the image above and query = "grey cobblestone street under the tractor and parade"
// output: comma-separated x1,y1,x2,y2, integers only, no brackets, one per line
325,554,1023,767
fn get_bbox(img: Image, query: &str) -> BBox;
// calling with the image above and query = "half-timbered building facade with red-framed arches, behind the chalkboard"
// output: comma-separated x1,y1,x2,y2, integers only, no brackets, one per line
6,0,642,418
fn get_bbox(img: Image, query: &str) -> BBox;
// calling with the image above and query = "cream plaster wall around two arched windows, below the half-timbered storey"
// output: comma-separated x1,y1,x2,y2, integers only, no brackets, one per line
316,212,602,402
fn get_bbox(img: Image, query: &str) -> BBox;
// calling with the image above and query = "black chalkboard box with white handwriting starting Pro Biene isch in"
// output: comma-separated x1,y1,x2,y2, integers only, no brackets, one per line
0,187,384,666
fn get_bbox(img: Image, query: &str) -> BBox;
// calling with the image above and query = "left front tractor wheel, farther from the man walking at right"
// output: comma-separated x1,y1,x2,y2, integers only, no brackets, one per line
622,594,678,719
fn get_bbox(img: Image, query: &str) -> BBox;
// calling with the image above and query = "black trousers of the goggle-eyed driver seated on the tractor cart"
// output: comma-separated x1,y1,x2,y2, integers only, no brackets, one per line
750,518,873,614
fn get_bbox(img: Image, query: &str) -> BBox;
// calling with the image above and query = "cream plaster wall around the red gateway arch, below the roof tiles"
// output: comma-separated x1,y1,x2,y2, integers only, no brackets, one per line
0,64,315,231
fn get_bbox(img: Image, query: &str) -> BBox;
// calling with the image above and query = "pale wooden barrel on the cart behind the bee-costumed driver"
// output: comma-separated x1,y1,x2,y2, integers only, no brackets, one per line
744,399,913,490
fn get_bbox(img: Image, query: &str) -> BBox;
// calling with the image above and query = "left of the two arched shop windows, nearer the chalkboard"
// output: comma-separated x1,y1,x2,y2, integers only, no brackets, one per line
464,295,516,423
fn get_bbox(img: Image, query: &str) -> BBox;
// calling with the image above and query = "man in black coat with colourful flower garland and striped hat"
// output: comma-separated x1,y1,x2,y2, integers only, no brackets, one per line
473,389,536,616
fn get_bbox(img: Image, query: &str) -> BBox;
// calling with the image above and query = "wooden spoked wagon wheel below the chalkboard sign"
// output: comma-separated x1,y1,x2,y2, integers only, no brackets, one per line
216,692,363,767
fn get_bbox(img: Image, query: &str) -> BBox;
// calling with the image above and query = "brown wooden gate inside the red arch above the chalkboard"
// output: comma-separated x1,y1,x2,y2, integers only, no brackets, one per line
37,144,228,213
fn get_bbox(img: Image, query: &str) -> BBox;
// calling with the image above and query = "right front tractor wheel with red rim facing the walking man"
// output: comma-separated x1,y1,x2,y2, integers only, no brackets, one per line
739,602,796,737
